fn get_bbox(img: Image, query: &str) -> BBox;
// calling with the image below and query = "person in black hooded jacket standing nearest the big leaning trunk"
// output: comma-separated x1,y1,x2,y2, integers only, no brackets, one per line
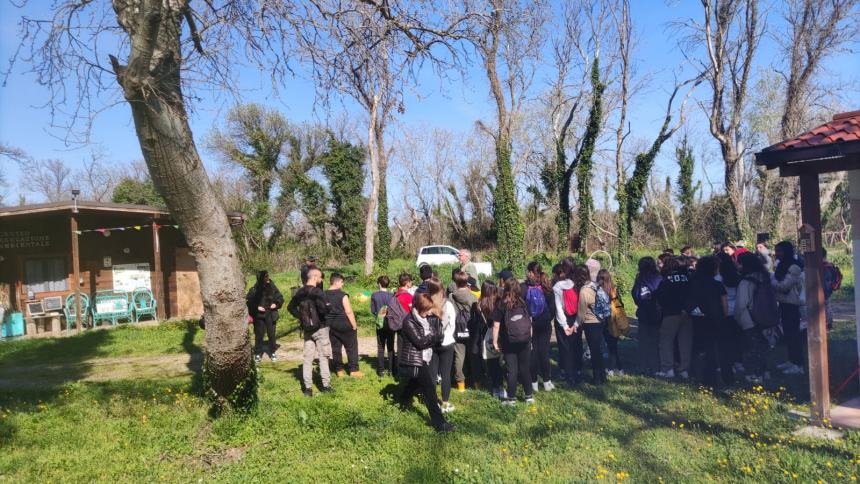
245,271,284,363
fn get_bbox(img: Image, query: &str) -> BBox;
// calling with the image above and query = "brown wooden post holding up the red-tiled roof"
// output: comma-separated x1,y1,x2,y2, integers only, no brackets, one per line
800,173,830,426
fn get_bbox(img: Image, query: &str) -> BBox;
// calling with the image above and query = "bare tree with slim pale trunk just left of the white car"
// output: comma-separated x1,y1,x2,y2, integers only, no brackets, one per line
296,0,465,274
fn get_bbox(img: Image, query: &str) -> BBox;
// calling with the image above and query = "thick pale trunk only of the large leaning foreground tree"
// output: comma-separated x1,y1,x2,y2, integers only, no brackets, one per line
111,0,250,399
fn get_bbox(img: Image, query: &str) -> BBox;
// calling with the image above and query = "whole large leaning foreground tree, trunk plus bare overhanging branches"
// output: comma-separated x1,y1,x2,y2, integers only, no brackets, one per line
7,0,310,408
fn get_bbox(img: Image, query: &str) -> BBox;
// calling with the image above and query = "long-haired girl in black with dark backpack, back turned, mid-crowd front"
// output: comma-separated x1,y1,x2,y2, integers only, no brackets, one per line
493,277,535,406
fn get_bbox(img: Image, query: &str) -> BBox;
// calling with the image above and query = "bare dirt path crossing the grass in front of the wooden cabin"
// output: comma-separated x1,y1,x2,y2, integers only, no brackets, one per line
0,336,376,391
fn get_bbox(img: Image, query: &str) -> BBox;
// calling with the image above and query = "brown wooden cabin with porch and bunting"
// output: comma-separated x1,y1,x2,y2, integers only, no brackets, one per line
0,201,242,333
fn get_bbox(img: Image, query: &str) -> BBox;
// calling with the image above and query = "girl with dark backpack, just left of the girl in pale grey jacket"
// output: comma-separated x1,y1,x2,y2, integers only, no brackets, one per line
735,253,777,384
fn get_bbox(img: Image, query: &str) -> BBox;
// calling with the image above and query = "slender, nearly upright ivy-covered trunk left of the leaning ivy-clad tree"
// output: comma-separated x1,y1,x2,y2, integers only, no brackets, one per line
576,56,606,252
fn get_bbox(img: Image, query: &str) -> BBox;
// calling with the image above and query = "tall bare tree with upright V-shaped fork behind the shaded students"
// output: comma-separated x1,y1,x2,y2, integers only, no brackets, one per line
682,0,764,237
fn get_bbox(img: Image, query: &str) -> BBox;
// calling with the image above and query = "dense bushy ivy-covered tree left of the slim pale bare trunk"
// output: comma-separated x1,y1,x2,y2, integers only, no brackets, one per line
320,136,367,263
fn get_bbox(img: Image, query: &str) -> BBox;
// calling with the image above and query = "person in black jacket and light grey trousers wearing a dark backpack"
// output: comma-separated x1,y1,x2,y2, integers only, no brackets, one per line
287,268,332,397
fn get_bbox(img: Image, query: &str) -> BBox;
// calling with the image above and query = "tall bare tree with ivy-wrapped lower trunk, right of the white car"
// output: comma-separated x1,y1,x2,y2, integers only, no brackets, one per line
470,0,547,267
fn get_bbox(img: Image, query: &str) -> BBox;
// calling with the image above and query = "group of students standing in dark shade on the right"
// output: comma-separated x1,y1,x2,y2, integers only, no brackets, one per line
632,241,841,386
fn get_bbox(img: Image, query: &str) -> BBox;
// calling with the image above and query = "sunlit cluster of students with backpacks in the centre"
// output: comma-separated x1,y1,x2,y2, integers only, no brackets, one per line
371,255,628,431
